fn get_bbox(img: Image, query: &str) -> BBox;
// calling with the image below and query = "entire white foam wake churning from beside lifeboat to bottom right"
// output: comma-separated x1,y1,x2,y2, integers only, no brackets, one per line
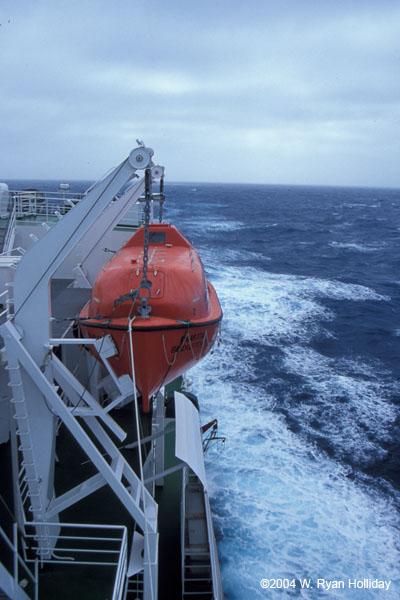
191,264,400,600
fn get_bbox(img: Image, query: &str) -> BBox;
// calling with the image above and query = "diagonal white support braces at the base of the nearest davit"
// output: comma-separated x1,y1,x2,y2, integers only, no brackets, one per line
2,321,158,589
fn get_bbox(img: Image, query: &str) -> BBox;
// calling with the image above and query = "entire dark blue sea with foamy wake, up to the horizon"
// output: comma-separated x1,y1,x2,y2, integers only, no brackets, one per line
3,182,400,600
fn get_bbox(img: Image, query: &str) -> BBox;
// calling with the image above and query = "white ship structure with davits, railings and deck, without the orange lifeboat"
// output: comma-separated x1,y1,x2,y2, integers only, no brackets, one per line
0,143,223,600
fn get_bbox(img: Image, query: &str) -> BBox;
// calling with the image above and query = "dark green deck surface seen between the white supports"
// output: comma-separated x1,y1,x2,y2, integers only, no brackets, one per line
34,406,182,600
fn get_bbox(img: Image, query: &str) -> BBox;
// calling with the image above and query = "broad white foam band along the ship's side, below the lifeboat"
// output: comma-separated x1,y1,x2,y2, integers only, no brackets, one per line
191,340,400,600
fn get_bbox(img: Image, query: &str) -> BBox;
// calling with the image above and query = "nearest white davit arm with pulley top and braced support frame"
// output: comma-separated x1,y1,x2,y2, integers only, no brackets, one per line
1,146,158,600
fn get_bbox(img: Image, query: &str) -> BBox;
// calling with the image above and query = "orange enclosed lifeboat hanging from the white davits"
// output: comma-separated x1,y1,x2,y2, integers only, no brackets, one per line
78,223,222,412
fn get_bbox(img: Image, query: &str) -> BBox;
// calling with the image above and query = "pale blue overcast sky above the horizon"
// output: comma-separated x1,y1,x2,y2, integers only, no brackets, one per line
0,0,400,187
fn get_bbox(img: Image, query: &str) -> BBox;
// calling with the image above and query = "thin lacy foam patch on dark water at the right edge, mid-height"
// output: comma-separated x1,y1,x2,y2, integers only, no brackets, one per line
284,346,400,468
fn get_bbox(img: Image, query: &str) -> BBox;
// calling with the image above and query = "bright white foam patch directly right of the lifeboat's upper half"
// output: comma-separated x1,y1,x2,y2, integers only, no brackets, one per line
206,262,390,344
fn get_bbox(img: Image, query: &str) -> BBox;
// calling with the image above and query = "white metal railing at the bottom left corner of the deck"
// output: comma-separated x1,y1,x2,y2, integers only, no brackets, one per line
25,522,128,600
